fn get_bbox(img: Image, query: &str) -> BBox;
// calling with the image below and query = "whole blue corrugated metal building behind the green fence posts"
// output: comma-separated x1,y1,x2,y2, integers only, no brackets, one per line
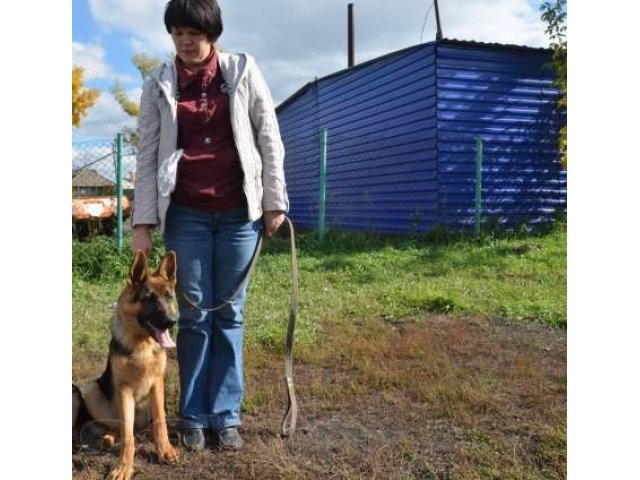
277,40,566,233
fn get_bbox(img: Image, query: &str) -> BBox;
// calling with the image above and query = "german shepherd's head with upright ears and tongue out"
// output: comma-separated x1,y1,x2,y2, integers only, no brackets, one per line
127,250,177,348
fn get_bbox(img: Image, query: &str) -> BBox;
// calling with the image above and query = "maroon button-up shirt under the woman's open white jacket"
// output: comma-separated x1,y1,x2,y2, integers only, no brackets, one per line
171,49,247,211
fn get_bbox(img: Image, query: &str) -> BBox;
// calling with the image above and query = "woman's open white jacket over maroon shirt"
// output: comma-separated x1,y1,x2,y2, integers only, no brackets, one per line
132,52,289,231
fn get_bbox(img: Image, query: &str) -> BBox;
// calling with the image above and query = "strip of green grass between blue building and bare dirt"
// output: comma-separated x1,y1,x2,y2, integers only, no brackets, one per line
73,224,566,352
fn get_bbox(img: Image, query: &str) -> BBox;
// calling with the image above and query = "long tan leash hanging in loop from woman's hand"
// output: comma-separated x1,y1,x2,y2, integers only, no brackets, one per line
180,216,298,437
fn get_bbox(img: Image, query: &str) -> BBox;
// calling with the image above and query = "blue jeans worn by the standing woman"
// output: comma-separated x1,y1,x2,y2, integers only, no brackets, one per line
164,204,262,430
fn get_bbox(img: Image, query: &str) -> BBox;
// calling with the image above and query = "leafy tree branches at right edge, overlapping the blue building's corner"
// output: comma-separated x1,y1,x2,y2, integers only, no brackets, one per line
540,0,567,167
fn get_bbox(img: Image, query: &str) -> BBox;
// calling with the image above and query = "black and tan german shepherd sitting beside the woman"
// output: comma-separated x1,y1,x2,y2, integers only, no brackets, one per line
73,250,177,480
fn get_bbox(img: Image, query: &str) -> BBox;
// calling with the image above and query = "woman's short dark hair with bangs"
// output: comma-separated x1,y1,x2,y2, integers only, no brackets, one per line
164,0,222,43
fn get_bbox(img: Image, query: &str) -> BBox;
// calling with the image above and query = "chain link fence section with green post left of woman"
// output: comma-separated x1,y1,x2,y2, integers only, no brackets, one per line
71,137,135,240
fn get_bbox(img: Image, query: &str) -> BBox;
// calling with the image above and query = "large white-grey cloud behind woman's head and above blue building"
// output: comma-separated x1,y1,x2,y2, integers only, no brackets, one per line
81,0,547,108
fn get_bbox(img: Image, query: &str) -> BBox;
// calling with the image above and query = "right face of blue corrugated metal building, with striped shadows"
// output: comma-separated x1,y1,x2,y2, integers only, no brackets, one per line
437,42,566,229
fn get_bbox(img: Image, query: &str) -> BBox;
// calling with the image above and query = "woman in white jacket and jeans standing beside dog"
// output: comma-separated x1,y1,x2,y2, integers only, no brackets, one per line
132,0,289,449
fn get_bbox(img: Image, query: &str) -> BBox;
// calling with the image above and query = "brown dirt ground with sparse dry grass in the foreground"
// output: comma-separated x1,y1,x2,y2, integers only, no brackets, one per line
72,316,566,480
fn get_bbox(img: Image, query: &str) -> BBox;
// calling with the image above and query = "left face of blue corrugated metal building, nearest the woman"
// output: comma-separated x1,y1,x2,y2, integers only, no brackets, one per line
278,44,438,232
